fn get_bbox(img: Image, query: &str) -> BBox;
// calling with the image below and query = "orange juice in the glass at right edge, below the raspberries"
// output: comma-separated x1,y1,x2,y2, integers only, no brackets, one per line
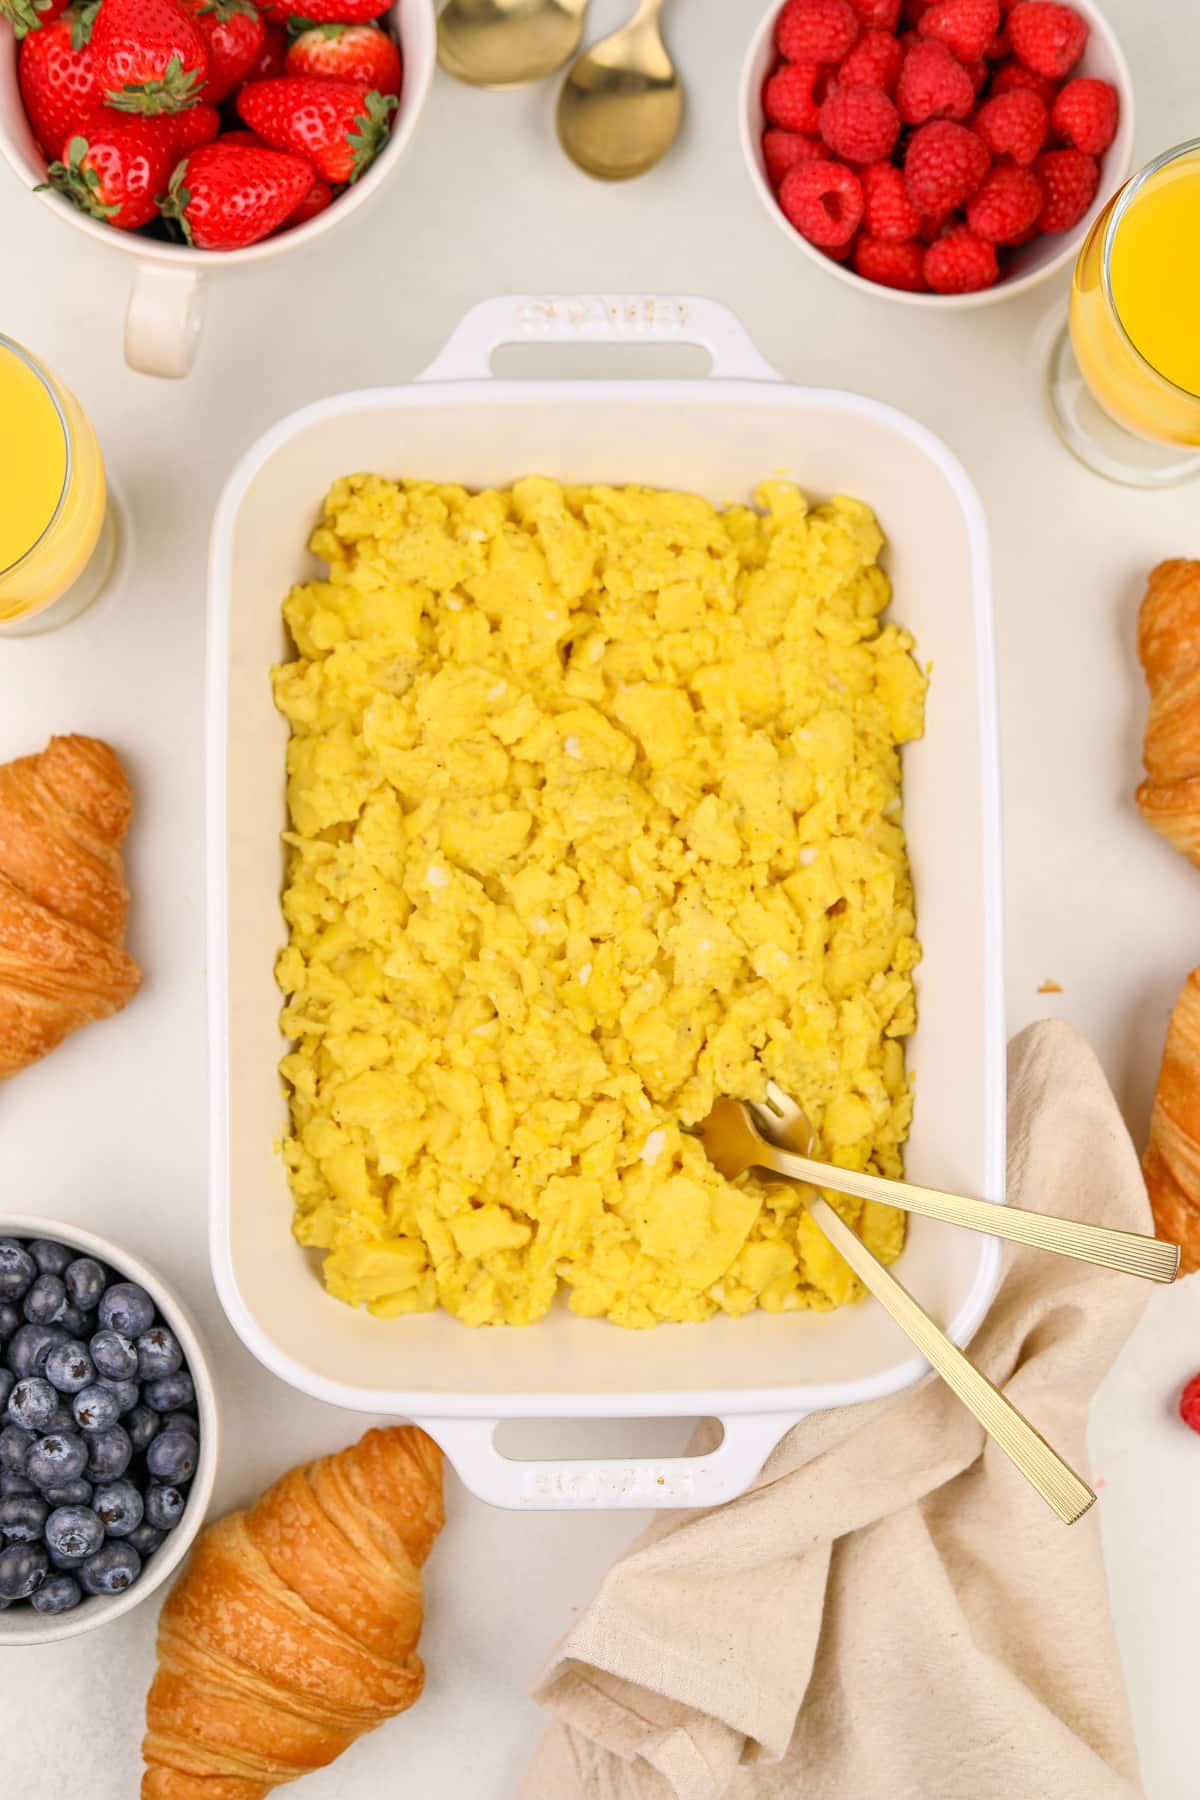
1070,144,1200,445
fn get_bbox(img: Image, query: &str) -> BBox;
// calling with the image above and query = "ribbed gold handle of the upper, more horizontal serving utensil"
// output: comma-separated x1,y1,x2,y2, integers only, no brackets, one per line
763,1145,1178,1282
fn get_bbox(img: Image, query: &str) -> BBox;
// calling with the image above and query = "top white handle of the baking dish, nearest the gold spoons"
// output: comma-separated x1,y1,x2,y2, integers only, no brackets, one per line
417,293,781,382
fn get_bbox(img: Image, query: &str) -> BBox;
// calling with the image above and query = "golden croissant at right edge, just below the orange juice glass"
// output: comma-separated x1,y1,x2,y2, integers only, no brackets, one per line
1137,558,1200,866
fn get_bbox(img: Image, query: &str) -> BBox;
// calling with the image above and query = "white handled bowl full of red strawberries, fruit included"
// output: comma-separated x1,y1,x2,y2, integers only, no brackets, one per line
0,0,437,374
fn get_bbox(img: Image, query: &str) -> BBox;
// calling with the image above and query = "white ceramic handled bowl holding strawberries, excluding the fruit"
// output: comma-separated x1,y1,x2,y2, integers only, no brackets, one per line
0,0,437,376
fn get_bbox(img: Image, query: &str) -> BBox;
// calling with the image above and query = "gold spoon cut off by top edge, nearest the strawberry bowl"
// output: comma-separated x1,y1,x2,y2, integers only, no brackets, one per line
437,0,588,88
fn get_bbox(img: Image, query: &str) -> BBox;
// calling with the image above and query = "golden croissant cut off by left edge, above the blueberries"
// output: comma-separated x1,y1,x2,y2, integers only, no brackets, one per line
0,738,142,1080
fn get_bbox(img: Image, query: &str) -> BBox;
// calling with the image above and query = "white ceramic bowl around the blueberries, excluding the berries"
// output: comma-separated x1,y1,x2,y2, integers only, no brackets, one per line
0,1213,218,1651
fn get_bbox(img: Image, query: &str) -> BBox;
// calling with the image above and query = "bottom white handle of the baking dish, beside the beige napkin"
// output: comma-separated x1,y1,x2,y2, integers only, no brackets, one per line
414,1413,804,1512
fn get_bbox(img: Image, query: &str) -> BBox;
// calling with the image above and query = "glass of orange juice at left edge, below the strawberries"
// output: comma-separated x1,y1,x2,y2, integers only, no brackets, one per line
0,335,117,637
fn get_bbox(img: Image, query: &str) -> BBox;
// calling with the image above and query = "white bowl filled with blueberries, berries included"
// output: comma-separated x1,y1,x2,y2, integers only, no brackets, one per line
0,1215,216,1649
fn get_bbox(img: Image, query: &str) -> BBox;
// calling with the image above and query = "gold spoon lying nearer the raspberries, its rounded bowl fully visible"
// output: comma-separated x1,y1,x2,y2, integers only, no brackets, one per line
558,0,684,182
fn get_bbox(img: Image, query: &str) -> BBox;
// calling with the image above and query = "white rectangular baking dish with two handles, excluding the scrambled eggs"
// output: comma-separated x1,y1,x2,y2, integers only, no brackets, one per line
209,297,1004,1507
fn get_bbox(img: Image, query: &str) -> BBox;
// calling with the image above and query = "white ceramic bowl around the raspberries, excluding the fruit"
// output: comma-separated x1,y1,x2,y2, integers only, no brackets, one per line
738,0,1133,310
